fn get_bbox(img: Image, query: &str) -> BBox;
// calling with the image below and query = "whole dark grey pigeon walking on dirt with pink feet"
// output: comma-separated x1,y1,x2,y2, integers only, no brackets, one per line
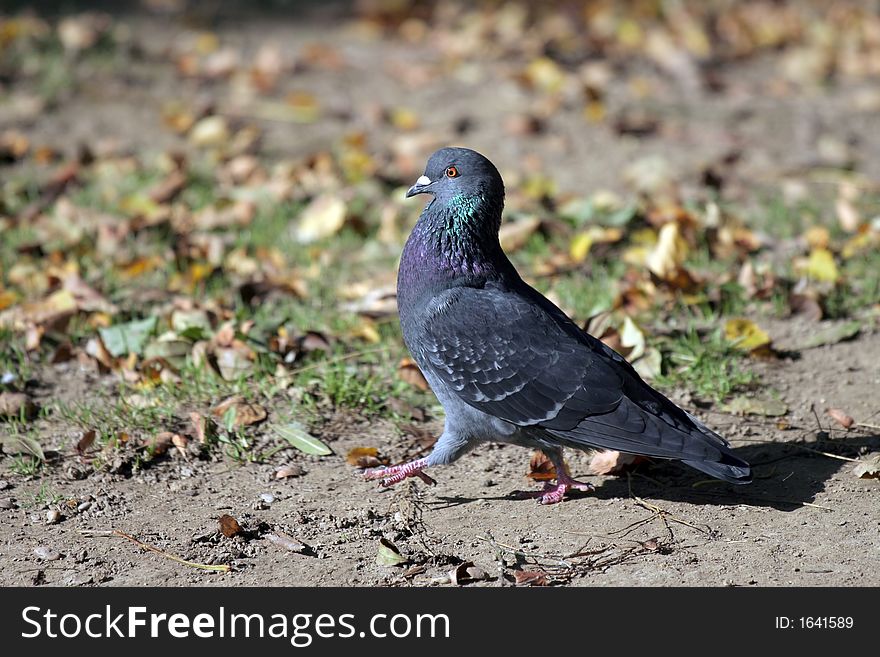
364,148,751,504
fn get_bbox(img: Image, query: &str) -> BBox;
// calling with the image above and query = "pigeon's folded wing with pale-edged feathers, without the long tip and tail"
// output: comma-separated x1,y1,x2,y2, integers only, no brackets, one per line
416,286,623,426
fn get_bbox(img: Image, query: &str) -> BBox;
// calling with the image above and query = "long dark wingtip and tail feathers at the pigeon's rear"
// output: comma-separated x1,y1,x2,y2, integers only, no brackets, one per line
543,391,752,484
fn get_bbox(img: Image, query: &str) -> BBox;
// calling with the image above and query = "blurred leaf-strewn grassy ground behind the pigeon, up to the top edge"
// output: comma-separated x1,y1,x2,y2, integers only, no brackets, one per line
0,0,880,584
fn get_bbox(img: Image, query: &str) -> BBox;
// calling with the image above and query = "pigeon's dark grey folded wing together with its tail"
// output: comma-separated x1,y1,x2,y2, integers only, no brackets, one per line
415,285,749,482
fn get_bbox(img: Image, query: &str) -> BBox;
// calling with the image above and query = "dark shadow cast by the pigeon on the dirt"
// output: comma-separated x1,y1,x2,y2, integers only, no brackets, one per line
428,434,880,511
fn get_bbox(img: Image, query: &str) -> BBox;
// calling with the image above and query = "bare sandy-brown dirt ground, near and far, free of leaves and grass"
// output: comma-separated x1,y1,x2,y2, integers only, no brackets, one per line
0,2,880,586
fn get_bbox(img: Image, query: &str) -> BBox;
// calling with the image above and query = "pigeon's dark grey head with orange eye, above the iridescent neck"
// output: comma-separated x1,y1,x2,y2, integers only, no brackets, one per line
406,148,504,206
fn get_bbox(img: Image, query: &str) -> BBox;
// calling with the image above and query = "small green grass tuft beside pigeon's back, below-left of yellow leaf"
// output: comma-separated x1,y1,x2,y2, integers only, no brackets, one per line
655,329,757,402
